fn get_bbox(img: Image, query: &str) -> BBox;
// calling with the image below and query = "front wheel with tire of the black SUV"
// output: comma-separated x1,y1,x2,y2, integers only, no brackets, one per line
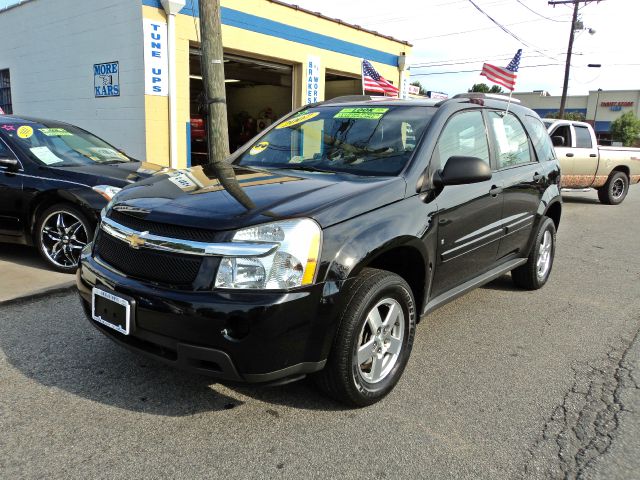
314,268,416,407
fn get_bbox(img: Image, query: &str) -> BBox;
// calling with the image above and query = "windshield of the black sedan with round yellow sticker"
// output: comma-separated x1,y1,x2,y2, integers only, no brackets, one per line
0,122,130,167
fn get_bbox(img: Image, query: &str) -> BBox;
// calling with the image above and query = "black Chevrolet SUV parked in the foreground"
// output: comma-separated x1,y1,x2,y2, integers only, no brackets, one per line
78,94,561,406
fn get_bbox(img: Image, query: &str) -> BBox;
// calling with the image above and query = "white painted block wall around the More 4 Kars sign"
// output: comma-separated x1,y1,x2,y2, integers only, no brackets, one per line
0,0,145,159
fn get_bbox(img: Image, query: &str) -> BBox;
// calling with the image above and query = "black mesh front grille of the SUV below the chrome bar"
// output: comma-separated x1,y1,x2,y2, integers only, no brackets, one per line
94,230,203,286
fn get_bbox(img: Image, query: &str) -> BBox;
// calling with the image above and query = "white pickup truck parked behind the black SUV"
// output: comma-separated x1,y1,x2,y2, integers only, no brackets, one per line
543,118,640,205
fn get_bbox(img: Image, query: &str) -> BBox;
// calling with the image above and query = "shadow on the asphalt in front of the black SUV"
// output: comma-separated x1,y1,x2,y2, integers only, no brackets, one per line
0,294,342,417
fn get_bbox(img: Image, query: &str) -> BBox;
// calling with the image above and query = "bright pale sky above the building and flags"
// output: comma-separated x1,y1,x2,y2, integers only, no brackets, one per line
287,0,640,95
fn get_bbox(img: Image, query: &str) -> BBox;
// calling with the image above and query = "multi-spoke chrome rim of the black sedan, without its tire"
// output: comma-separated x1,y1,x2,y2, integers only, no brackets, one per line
40,211,89,268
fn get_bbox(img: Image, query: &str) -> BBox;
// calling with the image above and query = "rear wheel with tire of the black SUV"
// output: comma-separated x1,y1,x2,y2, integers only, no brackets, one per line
511,217,556,290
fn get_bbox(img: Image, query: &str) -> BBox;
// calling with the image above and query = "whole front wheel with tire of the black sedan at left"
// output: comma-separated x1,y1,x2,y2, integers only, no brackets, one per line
33,203,93,273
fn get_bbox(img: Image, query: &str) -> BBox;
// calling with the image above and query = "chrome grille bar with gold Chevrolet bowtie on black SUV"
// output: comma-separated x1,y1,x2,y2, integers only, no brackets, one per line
100,217,278,257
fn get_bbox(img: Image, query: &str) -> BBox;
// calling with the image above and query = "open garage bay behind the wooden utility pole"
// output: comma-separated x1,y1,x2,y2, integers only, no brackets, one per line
189,48,293,165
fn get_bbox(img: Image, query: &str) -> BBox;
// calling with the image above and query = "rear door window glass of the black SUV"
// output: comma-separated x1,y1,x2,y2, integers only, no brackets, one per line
487,111,535,169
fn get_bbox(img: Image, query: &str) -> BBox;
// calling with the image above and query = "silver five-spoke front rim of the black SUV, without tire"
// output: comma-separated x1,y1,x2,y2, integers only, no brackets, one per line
354,298,405,383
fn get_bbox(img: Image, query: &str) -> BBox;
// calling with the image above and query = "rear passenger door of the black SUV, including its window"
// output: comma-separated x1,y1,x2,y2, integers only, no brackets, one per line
486,110,548,259
